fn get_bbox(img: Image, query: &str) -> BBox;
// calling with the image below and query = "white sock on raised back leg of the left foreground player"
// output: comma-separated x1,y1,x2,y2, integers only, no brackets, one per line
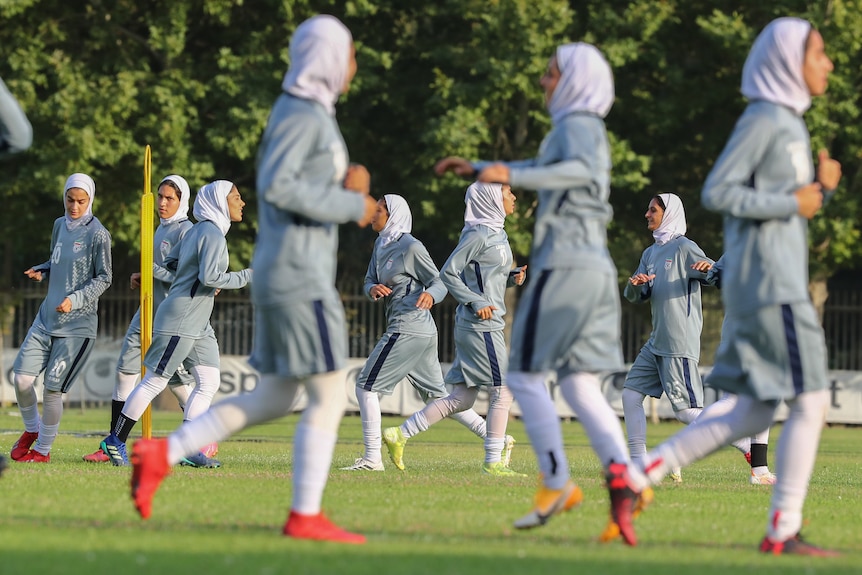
168,374,301,465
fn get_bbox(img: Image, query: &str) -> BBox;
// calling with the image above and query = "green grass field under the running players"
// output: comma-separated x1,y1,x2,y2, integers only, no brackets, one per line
0,408,862,575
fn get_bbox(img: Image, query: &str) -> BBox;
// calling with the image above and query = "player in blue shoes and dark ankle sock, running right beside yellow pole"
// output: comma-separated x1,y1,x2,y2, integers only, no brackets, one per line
102,180,252,467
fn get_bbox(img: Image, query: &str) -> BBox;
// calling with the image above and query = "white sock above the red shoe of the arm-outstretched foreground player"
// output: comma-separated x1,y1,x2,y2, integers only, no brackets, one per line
558,372,629,469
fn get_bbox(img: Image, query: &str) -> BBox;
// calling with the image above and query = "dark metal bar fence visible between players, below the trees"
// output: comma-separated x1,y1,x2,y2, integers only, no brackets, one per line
4,283,862,371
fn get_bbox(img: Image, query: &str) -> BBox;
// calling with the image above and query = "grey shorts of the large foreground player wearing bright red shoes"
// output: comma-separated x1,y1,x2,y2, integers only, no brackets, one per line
249,295,347,378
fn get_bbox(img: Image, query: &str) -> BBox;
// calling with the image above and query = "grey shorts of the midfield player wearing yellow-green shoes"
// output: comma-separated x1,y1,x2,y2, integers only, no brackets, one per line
444,326,509,387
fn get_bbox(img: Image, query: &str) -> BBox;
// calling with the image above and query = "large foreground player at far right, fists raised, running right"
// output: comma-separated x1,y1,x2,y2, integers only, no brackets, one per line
630,18,841,556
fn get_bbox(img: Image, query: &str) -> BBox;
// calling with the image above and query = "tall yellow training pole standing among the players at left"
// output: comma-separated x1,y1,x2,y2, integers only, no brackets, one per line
141,144,155,439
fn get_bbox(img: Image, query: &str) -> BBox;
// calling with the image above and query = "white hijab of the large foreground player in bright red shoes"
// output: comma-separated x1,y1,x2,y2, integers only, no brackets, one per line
281,14,353,115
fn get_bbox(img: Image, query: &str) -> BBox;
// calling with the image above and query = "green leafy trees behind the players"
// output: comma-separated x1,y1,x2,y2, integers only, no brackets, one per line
0,0,862,283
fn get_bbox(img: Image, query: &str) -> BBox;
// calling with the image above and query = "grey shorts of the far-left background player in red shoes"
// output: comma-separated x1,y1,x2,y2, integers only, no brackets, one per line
12,324,96,393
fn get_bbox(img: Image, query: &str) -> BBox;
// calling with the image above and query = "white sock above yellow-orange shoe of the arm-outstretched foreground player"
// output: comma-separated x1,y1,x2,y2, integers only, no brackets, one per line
506,371,572,489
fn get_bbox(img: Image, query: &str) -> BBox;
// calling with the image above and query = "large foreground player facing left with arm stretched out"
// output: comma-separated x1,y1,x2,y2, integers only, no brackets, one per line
435,42,638,545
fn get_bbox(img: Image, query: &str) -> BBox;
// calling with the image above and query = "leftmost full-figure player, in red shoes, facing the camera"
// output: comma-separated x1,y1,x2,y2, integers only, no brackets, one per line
10,174,112,463
